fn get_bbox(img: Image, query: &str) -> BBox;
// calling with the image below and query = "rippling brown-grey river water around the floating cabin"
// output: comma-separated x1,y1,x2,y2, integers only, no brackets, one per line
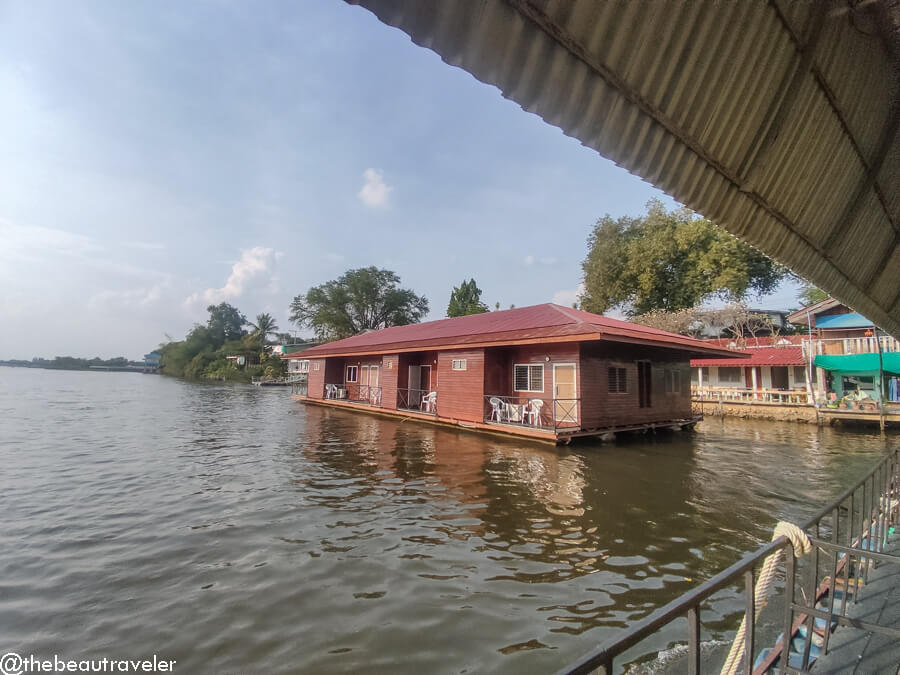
0,368,896,673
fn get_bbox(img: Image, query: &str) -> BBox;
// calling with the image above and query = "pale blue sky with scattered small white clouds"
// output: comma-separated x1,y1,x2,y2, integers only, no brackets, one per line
0,0,798,359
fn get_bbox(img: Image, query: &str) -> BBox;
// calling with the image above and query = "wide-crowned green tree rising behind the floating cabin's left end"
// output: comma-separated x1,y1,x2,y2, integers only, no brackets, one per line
291,267,428,340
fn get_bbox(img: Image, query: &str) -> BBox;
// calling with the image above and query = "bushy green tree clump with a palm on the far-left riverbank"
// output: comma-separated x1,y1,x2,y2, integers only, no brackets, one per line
159,302,285,382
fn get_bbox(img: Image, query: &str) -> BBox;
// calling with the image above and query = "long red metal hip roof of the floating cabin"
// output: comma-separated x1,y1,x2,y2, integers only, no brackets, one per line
284,303,742,359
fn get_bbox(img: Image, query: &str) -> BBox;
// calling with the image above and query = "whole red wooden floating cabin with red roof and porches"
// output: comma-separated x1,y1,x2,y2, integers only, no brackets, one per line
284,304,741,442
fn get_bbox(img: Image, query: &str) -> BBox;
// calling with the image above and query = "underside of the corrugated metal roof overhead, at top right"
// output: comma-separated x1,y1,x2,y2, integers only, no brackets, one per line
351,0,900,336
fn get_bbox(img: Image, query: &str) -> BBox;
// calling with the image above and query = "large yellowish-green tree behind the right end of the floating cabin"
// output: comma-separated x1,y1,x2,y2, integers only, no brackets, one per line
581,200,788,316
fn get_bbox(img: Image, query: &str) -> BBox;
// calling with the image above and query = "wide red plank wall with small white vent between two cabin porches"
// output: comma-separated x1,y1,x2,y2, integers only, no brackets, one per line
437,349,484,422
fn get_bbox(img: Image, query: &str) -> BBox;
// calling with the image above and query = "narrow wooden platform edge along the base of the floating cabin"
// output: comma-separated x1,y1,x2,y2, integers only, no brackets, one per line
291,394,702,445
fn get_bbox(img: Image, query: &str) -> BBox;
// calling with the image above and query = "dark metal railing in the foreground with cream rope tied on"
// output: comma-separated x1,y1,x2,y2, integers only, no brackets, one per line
560,448,900,675
